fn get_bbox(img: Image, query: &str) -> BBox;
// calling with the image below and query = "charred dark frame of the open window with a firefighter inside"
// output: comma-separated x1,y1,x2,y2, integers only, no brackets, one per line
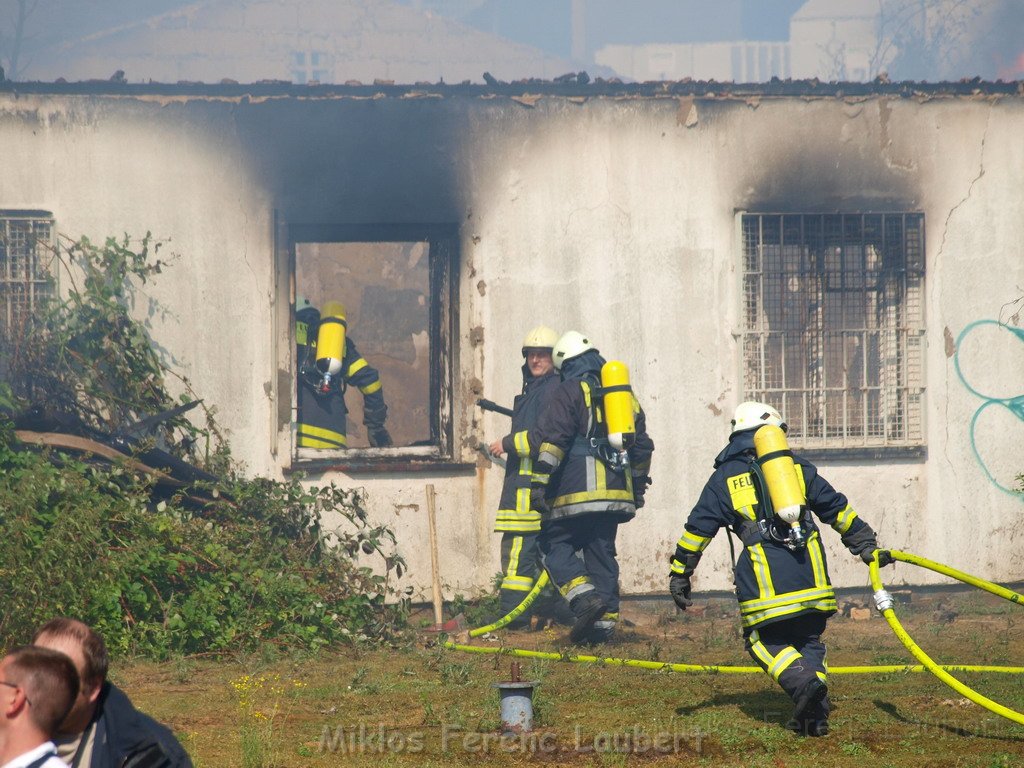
275,220,464,473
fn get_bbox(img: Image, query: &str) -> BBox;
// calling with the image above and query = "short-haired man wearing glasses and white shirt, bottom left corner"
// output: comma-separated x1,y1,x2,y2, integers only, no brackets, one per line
0,645,78,768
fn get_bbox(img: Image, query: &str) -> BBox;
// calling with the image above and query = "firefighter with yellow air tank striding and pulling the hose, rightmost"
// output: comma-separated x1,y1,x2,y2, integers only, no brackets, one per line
669,401,888,736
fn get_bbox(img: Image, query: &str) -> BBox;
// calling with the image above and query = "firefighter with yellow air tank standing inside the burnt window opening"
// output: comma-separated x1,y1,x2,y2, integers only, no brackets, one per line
295,296,393,450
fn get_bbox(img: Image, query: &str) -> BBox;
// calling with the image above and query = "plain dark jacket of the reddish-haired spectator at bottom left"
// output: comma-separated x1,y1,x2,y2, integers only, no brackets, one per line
90,683,191,768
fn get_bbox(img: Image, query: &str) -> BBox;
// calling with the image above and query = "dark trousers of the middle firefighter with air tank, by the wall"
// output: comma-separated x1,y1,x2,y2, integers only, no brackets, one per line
541,512,621,630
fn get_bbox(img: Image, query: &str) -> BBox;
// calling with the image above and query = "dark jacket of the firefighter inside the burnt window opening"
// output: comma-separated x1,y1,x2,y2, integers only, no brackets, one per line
295,310,387,449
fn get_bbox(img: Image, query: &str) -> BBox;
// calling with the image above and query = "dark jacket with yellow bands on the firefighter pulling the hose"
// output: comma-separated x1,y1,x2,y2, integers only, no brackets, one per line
672,430,877,629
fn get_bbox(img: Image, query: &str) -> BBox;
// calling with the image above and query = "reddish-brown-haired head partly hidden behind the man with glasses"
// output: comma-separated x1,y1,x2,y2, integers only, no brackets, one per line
32,617,108,733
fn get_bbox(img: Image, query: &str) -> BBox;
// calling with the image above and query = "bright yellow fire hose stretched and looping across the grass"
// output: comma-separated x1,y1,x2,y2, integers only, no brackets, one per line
441,550,1024,708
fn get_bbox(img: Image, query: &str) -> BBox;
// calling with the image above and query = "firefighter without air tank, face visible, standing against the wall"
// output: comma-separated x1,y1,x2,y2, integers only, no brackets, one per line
489,326,572,629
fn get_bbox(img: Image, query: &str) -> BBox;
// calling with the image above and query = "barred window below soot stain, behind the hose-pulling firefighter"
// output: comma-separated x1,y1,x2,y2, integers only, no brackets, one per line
741,213,925,450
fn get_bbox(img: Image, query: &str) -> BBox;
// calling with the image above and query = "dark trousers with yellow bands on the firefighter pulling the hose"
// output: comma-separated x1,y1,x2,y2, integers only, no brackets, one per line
744,613,828,721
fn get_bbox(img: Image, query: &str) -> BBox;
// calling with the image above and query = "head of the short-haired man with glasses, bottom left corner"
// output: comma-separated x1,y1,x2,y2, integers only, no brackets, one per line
0,645,79,740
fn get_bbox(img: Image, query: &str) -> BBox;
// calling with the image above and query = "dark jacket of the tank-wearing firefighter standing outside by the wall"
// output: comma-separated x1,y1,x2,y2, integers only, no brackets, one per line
529,350,654,521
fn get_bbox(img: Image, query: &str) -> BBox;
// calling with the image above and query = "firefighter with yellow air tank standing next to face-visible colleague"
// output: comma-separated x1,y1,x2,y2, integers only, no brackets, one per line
529,331,654,643
